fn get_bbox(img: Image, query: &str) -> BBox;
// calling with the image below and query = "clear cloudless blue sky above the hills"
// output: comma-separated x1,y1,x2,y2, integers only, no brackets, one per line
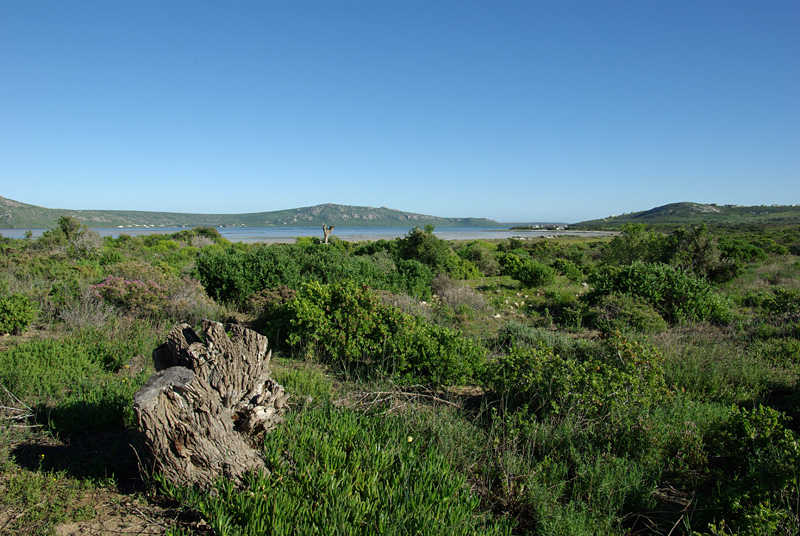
0,0,800,222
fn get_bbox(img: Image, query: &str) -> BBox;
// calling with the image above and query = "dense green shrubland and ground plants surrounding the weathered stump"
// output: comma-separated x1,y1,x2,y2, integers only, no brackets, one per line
0,218,800,535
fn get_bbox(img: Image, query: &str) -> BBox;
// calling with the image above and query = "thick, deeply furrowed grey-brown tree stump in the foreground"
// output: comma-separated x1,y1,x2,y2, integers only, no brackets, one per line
133,321,288,487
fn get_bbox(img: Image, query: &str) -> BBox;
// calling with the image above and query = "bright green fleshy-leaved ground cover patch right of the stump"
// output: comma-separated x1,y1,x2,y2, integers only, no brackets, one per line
165,405,510,535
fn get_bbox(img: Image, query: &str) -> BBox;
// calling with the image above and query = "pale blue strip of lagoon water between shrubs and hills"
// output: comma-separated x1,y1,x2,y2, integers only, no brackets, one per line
0,227,610,243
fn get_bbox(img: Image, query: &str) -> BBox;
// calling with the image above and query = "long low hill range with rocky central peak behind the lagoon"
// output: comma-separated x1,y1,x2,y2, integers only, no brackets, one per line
0,196,499,229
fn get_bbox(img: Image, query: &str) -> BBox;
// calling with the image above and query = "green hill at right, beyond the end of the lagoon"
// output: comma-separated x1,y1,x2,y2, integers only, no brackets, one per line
571,203,800,227
